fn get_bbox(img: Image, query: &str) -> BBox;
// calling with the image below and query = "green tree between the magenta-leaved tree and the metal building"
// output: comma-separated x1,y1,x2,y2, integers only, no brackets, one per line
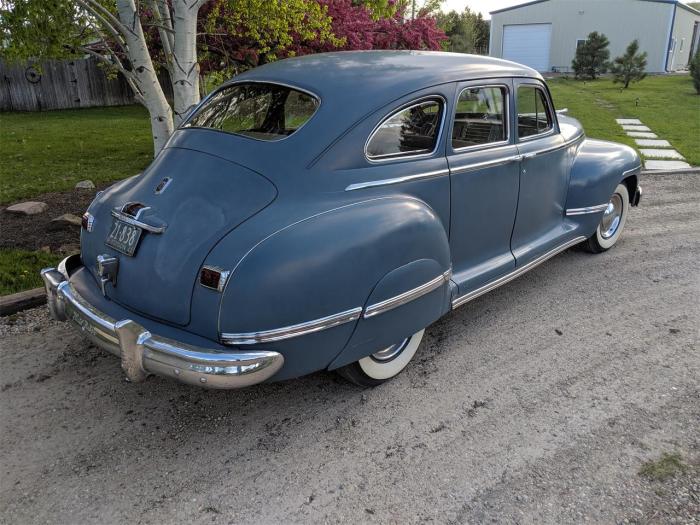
435,7,490,53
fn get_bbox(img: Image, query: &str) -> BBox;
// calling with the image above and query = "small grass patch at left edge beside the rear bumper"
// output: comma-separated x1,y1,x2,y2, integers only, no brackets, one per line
0,250,62,295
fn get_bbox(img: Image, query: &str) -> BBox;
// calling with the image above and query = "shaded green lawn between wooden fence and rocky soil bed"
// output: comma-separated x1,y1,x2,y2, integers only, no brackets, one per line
0,106,153,204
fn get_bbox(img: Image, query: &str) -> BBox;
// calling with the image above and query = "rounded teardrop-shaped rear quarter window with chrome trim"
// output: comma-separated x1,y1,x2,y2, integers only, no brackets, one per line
365,100,443,160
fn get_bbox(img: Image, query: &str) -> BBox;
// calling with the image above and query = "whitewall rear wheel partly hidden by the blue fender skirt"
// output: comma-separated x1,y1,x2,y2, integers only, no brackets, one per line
337,329,425,386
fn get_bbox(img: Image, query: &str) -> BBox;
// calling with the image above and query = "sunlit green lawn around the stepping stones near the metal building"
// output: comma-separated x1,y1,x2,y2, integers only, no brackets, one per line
547,75,700,166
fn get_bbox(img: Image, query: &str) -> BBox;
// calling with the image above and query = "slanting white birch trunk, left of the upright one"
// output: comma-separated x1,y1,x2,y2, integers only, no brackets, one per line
117,0,174,155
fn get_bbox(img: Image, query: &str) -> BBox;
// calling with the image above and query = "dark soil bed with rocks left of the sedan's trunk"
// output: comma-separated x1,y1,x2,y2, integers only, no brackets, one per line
0,184,109,251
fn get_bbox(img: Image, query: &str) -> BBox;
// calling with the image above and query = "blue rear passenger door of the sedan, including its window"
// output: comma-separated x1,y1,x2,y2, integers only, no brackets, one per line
446,79,519,295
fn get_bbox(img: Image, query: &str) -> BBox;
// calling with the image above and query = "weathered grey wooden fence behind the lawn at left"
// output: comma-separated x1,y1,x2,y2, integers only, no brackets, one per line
0,58,172,111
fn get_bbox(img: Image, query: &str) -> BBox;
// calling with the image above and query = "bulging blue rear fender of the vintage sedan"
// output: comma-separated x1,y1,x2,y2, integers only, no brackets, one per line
219,196,450,379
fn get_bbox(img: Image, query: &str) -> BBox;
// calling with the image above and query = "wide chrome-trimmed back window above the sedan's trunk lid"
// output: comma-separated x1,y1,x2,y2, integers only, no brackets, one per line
184,82,319,140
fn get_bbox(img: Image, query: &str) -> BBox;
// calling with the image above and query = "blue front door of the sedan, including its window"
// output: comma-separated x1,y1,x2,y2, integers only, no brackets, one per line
511,79,570,266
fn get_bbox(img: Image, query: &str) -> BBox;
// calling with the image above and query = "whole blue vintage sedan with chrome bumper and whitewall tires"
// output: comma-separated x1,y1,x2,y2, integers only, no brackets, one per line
42,51,641,388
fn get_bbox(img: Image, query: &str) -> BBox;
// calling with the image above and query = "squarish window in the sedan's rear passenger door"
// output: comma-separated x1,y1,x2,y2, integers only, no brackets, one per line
452,87,508,149
